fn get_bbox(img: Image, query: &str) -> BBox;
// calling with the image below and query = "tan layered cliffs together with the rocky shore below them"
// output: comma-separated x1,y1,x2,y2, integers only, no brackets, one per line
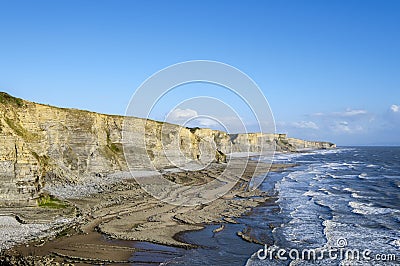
0,92,335,265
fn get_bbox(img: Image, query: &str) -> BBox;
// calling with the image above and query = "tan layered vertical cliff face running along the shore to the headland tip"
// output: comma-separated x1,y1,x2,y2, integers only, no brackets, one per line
0,93,335,206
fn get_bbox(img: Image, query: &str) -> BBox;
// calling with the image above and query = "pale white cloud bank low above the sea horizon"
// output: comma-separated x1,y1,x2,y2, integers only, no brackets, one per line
277,103,400,145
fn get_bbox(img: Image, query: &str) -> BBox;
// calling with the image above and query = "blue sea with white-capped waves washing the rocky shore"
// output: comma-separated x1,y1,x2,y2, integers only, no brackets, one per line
134,147,400,266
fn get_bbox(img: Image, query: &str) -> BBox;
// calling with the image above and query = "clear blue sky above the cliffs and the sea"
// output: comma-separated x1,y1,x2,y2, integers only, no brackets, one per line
0,0,400,145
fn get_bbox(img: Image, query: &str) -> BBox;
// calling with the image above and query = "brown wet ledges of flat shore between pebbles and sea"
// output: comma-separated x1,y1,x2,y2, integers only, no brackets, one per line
2,159,293,265
